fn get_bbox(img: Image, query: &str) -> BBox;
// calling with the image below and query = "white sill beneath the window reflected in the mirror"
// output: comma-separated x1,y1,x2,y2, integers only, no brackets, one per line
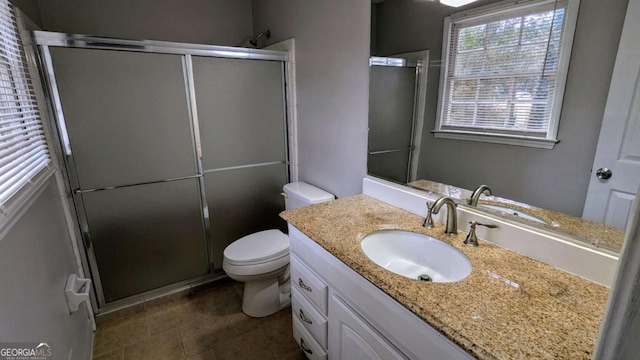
431,130,560,149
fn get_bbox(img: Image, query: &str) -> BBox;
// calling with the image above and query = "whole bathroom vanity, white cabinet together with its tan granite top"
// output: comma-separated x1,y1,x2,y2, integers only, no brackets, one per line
281,195,608,360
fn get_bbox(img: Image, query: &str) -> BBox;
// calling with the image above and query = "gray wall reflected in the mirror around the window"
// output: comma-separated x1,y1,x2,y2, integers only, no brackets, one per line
376,0,628,216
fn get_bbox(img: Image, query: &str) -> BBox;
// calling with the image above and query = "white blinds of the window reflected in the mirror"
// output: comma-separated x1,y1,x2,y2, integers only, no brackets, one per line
440,2,567,138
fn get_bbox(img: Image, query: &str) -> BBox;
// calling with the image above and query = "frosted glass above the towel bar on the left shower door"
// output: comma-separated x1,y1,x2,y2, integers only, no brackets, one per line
50,48,196,189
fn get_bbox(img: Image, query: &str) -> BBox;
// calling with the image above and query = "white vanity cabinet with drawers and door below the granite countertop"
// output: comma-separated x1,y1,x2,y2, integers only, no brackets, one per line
289,225,473,360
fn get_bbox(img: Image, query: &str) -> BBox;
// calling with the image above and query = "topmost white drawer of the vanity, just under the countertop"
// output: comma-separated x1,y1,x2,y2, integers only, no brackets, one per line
291,256,328,316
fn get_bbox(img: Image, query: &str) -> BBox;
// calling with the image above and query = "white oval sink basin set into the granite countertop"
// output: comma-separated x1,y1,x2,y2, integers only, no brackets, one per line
360,230,471,282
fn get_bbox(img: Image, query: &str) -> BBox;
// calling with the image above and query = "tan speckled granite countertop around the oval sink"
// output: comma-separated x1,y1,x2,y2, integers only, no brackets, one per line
280,195,609,359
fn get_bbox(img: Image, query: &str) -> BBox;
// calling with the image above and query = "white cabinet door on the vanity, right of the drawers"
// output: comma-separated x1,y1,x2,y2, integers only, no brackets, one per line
329,294,406,360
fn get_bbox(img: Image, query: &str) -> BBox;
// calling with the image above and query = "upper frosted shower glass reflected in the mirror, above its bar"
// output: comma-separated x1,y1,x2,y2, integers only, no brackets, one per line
369,66,416,152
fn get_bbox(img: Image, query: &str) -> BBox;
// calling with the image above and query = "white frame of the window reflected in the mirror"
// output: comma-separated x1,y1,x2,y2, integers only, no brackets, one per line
431,0,580,149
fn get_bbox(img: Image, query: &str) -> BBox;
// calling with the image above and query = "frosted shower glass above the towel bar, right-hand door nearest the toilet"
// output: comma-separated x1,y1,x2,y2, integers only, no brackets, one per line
193,56,285,170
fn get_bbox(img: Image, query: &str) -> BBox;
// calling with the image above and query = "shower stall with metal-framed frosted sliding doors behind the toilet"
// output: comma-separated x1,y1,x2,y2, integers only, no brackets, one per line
34,32,289,308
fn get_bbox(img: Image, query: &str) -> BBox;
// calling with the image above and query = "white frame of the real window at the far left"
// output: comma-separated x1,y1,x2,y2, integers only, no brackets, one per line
0,4,58,241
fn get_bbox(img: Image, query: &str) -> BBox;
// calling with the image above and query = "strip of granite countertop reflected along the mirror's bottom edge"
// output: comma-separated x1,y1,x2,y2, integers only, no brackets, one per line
407,180,625,252
